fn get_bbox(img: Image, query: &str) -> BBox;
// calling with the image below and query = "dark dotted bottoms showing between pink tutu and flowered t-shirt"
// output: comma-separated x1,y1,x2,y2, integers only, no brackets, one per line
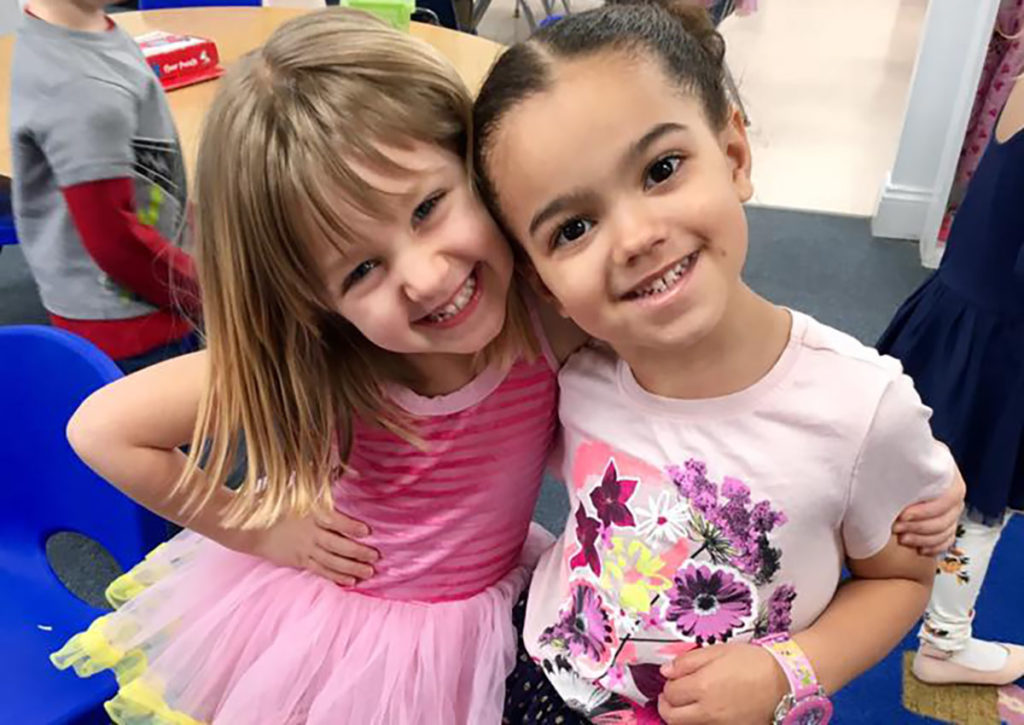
502,593,590,725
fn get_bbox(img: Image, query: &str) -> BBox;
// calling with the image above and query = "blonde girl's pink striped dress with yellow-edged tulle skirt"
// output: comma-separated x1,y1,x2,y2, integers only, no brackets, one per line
48,358,557,725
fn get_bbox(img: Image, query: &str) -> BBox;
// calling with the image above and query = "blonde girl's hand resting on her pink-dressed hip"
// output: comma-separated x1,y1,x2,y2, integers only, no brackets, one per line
251,511,379,587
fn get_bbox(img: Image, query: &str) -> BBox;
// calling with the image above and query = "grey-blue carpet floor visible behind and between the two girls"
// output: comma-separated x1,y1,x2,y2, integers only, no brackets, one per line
0,208,927,603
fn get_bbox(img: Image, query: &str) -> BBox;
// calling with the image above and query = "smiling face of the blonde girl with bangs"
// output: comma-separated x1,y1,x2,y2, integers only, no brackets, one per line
313,141,512,354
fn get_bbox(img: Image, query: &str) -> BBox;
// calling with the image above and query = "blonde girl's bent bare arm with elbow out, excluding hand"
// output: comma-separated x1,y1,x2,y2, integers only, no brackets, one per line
68,352,253,550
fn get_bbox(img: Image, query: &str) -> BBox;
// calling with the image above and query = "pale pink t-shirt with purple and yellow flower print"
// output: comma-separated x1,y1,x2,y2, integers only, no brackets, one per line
524,312,954,723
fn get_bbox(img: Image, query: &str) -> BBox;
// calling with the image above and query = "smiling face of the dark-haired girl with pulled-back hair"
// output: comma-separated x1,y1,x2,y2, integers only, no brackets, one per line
484,51,752,356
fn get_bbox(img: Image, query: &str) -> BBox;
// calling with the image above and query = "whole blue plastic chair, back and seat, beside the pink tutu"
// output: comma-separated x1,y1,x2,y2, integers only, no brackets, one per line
0,326,165,724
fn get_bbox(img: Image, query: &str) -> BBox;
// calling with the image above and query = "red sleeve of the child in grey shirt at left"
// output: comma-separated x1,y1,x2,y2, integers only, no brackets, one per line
61,177,199,309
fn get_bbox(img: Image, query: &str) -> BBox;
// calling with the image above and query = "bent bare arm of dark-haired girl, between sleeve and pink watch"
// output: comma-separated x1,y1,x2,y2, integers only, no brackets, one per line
794,538,935,692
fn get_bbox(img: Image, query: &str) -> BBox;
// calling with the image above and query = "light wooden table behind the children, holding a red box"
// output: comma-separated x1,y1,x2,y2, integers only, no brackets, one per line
0,7,502,176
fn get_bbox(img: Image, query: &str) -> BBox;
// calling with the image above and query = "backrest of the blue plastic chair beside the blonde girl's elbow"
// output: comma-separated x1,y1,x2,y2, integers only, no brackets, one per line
0,326,166,568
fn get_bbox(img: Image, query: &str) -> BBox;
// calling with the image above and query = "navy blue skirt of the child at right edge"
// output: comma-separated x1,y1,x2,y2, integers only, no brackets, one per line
878,271,1024,525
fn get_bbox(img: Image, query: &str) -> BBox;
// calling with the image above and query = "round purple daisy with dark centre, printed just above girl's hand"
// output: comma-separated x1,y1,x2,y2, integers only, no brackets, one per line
665,561,754,644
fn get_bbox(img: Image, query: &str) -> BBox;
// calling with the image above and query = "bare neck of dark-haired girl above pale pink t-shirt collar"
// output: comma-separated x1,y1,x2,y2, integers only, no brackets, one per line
618,285,792,399
